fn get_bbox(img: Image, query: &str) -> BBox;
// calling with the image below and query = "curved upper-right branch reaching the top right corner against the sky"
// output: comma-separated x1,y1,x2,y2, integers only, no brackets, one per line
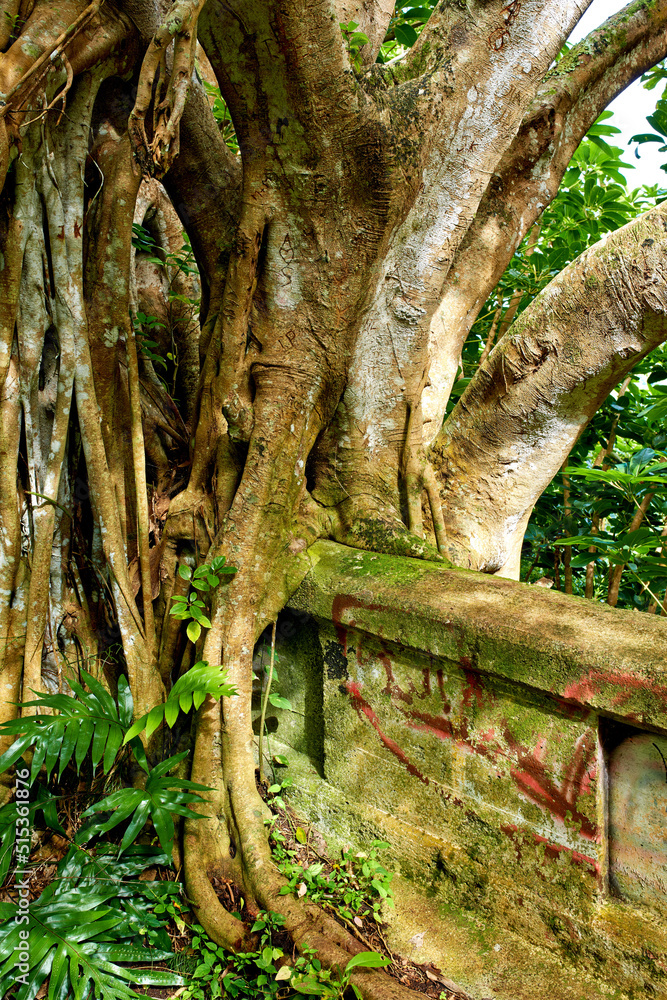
423,0,667,442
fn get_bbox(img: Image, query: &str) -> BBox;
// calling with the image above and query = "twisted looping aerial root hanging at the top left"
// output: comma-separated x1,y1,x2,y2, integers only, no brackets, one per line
128,0,206,176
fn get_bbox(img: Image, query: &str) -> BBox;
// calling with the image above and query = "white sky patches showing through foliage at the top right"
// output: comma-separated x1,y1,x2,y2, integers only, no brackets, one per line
569,0,667,188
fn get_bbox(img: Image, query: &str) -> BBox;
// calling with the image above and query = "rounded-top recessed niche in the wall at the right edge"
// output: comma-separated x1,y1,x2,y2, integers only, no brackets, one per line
600,719,667,910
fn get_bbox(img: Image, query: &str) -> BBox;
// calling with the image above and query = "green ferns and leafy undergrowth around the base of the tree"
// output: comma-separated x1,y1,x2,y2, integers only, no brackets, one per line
0,559,456,1000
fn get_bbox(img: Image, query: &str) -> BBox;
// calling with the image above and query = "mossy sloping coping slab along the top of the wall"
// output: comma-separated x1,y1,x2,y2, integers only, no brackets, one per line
289,541,667,730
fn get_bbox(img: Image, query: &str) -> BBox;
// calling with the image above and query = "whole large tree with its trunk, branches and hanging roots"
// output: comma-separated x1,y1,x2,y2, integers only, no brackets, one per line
0,0,667,997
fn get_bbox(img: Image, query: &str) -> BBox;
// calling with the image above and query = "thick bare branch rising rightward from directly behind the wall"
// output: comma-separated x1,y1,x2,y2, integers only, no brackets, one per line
433,206,667,576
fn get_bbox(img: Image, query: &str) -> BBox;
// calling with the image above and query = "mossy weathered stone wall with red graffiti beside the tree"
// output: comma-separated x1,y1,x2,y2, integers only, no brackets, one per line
260,543,667,1000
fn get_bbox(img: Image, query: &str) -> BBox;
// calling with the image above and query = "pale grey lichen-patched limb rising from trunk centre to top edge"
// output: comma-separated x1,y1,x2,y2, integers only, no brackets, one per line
326,0,585,506
